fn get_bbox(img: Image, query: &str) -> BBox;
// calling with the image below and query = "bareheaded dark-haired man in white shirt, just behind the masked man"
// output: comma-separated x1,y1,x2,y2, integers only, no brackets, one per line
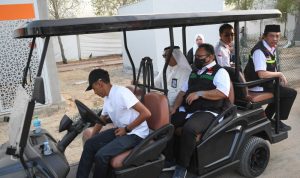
215,24,234,67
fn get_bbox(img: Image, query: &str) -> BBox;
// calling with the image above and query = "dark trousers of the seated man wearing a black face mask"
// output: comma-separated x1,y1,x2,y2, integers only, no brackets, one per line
165,112,215,167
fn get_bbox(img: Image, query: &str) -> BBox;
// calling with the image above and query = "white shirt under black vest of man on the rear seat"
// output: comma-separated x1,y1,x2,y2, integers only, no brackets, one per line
249,40,276,91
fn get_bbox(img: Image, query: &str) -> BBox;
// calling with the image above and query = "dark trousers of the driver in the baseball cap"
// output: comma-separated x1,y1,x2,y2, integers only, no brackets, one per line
76,128,142,178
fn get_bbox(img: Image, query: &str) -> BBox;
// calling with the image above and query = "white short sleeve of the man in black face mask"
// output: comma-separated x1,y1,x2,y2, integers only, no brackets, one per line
213,68,230,97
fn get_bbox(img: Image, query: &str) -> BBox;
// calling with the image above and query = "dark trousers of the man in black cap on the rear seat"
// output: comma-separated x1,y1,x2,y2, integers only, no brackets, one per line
265,86,297,120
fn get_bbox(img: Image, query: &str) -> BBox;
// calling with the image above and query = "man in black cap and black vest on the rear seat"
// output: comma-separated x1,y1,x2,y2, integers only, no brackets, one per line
244,25,297,131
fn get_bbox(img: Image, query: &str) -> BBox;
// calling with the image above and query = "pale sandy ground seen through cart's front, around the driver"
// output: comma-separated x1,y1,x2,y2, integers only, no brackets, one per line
0,65,132,163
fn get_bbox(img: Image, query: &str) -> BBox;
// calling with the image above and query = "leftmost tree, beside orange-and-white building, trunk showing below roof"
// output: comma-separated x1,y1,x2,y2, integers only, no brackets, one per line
48,0,79,64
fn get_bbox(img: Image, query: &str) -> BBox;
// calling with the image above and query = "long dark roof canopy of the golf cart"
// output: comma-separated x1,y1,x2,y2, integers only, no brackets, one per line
14,9,281,38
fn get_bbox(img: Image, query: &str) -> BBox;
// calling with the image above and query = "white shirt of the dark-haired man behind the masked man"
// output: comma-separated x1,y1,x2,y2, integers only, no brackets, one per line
215,40,231,67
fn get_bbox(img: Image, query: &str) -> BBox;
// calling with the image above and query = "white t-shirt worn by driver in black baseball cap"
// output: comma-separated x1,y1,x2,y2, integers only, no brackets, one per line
102,85,149,138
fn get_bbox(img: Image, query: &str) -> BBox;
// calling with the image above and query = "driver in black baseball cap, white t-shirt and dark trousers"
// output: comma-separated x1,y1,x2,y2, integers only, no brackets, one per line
77,69,151,178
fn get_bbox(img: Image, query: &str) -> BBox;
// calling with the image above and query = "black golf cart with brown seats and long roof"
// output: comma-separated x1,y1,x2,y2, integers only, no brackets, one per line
0,10,288,178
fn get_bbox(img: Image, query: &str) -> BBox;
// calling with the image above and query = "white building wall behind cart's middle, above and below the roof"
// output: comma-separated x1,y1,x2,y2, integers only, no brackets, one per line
119,0,224,72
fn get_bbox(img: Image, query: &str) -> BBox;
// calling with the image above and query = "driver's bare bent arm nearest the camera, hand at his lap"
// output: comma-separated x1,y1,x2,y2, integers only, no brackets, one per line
115,102,151,136
